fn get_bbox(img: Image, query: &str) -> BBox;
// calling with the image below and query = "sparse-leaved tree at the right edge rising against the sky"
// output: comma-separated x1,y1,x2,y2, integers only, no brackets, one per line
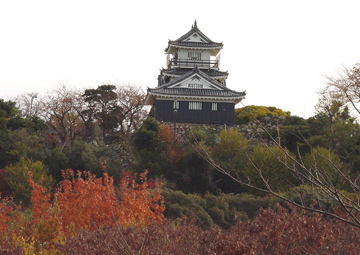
318,63,360,166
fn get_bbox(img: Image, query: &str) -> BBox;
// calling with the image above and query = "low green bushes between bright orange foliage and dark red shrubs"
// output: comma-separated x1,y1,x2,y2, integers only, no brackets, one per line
163,189,277,229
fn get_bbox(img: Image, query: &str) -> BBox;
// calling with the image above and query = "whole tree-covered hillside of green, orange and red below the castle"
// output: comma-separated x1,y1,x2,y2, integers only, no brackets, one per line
0,63,360,254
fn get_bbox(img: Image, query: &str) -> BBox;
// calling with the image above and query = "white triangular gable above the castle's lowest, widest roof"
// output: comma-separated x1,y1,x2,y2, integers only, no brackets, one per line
168,73,223,90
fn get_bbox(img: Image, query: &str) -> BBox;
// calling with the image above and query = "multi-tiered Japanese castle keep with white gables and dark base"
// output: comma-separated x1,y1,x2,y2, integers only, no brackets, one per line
145,21,245,125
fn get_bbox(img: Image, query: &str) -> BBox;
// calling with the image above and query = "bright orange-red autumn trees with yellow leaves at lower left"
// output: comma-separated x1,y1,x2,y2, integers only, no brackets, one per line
0,169,165,252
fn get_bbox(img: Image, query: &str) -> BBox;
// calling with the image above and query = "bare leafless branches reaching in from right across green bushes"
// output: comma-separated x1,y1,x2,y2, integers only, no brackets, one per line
194,103,360,228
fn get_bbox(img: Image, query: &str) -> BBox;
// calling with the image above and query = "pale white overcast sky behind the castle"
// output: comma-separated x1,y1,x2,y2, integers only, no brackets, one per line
0,0,360,118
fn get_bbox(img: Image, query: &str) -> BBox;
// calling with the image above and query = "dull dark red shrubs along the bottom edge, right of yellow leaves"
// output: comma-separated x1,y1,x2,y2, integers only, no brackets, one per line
59,204,360,255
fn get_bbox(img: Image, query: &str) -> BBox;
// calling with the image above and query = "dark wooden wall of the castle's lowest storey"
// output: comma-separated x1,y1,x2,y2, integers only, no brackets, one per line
154,100,235,125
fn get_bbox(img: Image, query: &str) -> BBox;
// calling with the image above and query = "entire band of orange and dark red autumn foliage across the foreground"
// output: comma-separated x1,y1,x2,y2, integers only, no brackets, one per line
0,169,360,255
